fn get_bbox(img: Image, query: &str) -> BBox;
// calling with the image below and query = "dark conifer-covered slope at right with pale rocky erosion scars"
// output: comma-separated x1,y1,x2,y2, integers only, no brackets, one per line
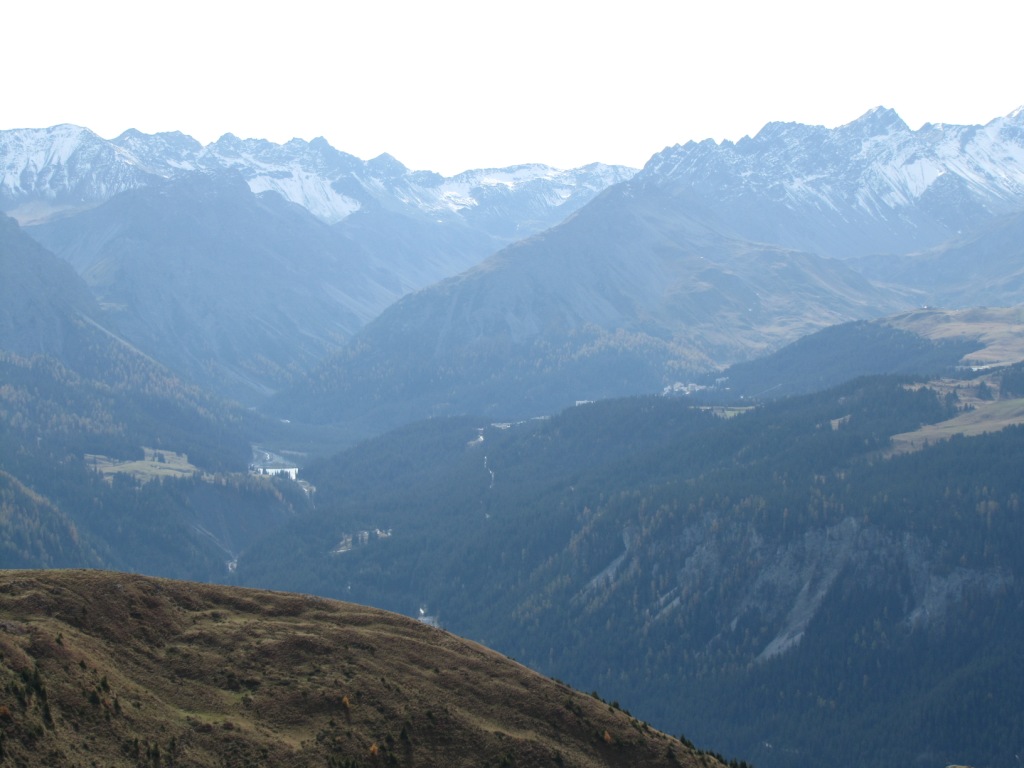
239,378,1024,767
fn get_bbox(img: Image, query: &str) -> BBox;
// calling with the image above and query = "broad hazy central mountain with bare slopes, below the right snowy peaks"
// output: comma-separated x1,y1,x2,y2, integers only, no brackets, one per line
272,162,908,434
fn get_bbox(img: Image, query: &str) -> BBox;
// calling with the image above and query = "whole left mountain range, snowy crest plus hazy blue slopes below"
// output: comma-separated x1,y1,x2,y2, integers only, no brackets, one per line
0,126,633,403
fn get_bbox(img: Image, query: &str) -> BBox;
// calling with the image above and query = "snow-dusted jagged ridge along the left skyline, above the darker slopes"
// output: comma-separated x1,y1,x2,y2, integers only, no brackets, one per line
0,125,636,228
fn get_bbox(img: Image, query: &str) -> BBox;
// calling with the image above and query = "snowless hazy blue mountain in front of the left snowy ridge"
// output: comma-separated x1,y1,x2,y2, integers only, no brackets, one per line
27,174,368,400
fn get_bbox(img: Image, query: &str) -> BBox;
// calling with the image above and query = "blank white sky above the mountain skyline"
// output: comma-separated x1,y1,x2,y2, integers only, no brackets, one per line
0,0,1024,175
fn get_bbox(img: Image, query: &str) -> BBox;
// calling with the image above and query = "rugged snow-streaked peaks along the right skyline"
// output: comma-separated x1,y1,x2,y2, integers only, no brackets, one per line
634,106,1024,257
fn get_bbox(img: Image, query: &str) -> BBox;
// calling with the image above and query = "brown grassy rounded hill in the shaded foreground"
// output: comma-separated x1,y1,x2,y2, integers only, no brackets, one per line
0,570,719,767
